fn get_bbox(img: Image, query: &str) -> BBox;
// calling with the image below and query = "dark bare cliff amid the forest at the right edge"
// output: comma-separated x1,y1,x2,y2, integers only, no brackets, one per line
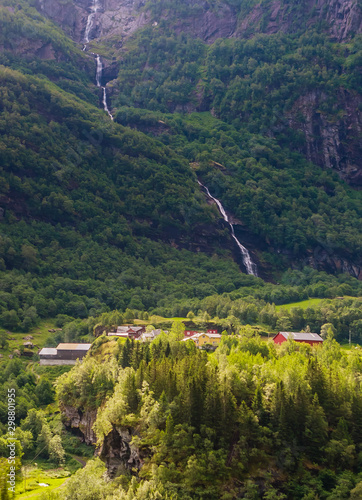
287,89,362,187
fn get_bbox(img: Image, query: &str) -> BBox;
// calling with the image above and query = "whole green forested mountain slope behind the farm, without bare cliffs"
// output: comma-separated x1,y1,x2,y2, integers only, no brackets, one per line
0,2,362,329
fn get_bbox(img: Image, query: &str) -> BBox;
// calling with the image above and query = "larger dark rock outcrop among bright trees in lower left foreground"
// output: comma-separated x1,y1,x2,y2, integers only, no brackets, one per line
99,427,143,476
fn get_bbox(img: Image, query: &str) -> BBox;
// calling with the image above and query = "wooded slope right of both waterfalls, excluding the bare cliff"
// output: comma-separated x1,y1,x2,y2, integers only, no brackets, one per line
117,28,362,267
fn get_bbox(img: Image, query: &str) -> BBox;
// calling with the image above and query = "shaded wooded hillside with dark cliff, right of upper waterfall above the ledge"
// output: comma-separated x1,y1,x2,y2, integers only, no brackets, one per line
110,28,362,187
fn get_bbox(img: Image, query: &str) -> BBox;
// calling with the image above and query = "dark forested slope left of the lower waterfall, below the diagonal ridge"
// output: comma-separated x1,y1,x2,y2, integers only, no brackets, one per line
0,61,266,330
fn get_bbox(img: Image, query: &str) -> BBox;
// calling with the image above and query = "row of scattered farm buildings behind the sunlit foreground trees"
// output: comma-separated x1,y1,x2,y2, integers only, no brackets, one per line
39,325,323,365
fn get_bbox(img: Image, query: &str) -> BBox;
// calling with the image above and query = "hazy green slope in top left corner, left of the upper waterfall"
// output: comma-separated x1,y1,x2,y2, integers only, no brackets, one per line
0,2,98,106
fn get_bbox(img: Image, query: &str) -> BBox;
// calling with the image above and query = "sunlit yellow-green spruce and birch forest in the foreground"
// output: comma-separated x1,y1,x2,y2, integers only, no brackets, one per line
48,330,362,500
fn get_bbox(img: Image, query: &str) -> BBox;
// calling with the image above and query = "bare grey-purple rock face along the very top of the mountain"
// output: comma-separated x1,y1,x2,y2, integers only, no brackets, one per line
36,0,362,46
